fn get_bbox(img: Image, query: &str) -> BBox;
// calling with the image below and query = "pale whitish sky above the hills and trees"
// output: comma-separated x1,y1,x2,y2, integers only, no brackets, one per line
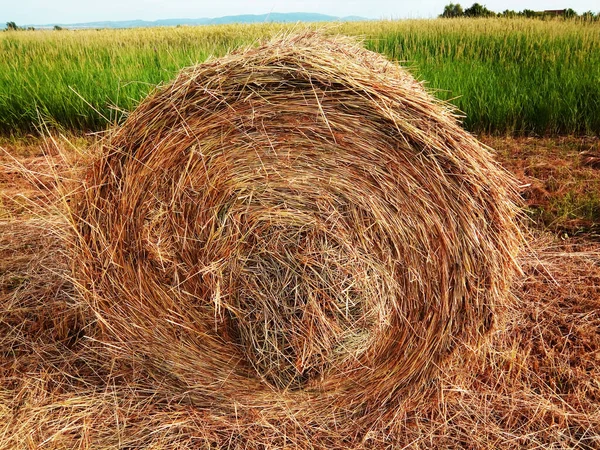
0,0,600,25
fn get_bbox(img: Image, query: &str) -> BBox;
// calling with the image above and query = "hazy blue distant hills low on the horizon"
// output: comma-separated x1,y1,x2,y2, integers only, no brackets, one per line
9,13,368,29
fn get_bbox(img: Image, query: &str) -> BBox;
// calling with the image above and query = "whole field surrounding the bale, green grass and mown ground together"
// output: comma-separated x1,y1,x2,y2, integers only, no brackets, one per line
0,19,600,450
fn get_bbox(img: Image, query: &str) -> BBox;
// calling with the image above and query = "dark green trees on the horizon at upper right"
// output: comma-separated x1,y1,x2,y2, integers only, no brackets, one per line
440,3,600,21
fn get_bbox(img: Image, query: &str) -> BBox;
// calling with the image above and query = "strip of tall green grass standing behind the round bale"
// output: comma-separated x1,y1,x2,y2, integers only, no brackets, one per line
0,19,600,135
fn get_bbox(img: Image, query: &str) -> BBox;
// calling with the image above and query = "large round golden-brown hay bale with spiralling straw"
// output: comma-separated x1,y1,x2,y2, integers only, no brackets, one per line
73,34,519,434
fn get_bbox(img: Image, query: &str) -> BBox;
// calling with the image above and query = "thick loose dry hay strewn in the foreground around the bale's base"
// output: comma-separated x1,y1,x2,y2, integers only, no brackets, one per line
0,218,600,450
